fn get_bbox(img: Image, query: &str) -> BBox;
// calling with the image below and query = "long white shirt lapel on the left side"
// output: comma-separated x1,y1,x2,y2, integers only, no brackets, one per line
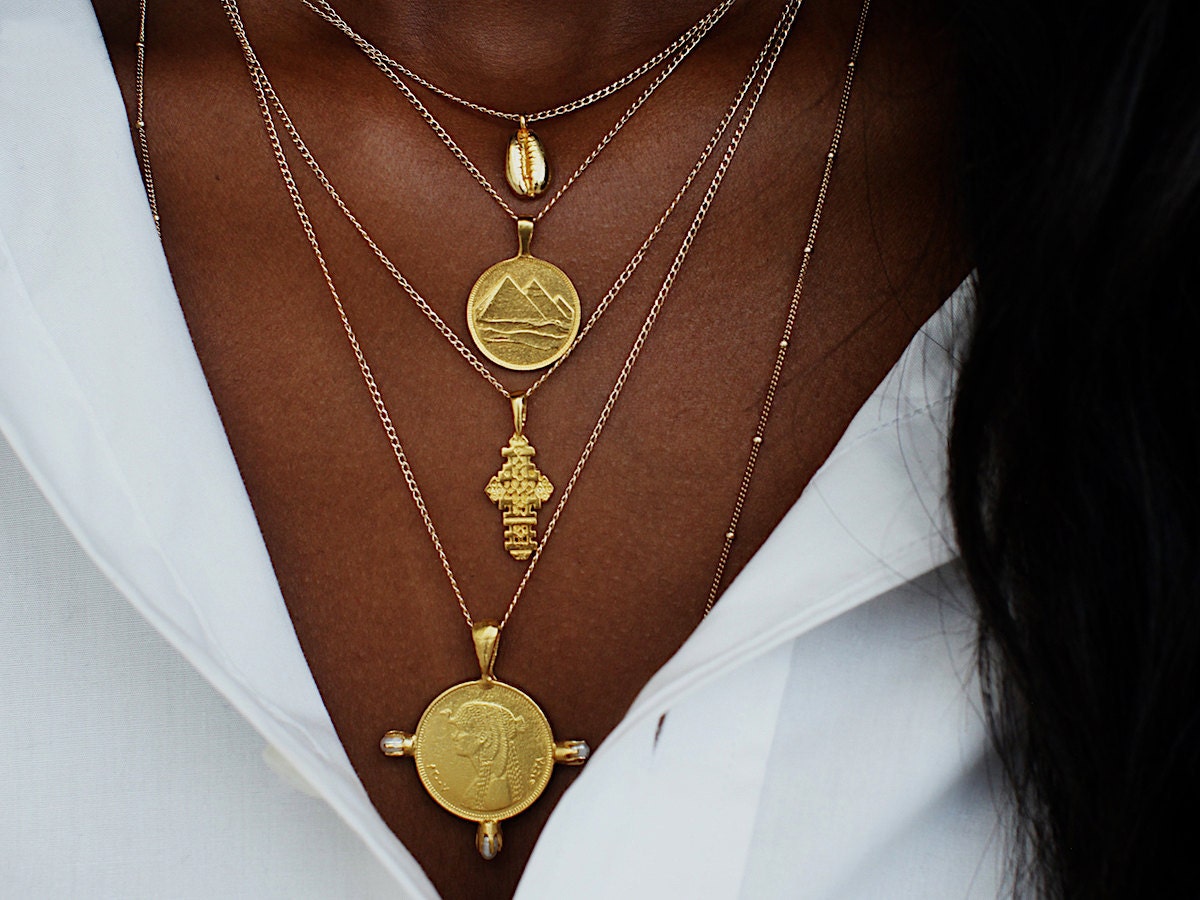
0,0,432,895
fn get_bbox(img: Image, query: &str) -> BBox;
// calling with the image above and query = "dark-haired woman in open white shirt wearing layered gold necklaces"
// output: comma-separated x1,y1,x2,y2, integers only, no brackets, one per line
0,0,1196,896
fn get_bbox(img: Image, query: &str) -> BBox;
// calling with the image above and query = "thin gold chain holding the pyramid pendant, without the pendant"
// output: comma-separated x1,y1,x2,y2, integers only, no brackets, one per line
302,0,732,229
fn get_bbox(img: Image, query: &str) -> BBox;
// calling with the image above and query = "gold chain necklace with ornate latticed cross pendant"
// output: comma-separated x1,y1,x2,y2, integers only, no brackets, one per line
230,5,788,560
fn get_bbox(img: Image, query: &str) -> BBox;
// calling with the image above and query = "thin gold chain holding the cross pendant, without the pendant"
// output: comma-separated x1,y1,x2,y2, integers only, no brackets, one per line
238,0,787,401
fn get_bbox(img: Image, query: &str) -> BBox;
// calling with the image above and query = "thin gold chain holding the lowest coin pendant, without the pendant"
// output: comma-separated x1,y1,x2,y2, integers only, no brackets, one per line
222,0,803,631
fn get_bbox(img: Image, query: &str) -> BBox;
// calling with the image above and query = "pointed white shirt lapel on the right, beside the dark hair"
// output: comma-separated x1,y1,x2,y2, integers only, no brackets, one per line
610,280,972,739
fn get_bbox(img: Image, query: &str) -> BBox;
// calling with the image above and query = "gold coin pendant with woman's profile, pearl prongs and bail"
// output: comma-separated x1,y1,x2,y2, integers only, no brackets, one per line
379,622,589,859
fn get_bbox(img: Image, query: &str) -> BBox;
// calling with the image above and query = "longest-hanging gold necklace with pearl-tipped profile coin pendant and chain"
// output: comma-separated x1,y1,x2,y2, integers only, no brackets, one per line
222,0,799,859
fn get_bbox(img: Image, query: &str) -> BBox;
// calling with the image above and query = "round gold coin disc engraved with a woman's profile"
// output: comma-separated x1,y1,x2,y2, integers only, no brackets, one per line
415,682,554,821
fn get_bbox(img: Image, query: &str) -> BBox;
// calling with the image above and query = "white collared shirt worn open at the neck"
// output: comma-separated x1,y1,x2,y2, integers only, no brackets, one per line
0,0,1002,899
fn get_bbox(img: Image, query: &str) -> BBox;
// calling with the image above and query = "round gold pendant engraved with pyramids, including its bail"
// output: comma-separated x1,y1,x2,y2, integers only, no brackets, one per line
467,218,580,371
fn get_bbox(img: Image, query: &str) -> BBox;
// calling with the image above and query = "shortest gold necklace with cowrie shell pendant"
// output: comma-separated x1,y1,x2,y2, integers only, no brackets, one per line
301,0,734,199
